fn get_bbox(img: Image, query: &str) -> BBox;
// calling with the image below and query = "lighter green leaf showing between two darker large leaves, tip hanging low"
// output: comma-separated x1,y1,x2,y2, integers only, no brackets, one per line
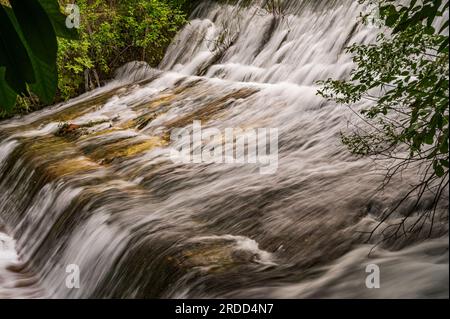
6,8,58,104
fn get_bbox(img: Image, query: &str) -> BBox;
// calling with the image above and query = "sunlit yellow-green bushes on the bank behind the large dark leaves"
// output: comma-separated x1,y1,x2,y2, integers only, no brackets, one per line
58,0,186,99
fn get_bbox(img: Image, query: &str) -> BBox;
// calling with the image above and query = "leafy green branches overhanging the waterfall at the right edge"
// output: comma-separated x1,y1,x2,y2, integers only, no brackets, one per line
318,0,449,240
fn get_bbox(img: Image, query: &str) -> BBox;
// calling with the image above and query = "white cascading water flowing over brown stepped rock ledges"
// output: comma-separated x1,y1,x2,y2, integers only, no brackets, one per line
0,0,449,298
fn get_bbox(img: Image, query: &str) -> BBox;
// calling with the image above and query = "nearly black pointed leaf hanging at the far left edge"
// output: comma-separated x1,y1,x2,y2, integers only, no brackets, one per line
0,5,36,93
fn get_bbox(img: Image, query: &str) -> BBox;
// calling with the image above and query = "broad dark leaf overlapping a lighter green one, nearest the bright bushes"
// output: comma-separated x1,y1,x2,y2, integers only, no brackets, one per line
9,0,58,64
